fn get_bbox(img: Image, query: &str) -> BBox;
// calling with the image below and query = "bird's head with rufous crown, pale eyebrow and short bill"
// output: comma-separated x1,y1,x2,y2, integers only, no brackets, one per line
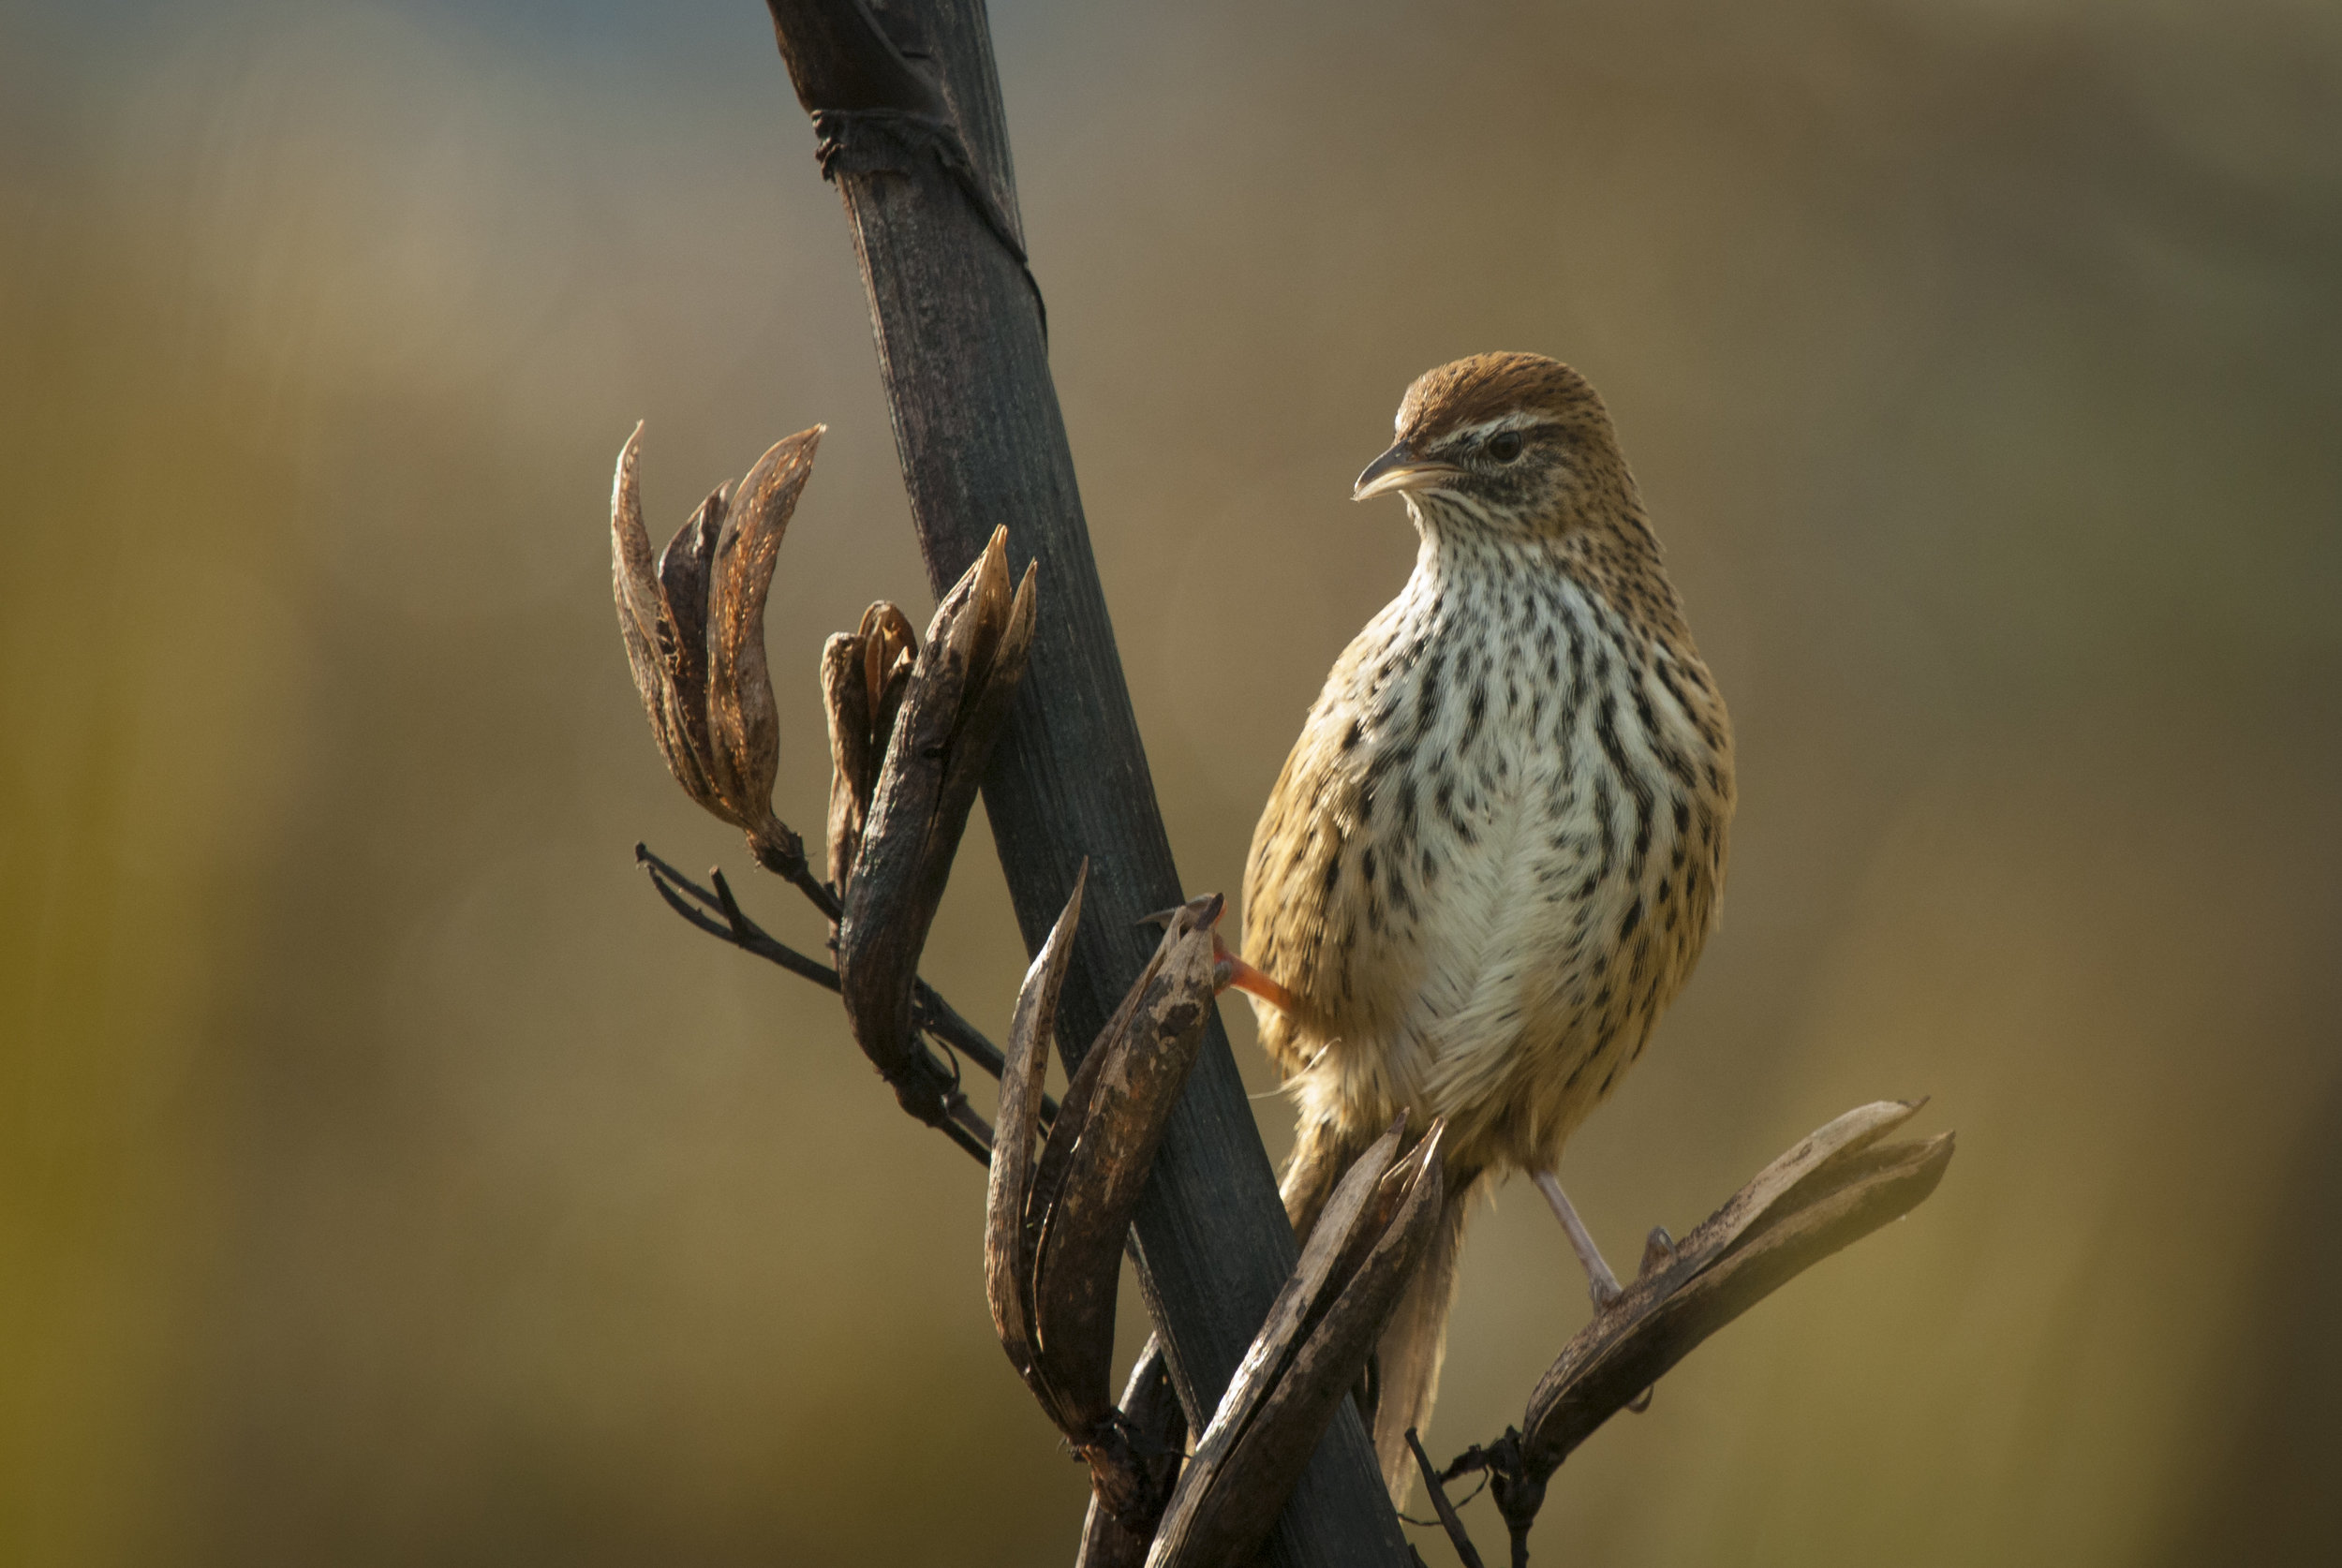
1352,353,1639,536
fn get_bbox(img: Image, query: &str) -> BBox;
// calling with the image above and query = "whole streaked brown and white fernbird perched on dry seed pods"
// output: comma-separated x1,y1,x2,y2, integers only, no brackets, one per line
1227,353,1733,1501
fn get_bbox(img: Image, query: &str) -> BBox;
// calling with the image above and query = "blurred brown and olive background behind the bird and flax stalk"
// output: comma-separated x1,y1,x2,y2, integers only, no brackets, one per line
0,0,2342,1568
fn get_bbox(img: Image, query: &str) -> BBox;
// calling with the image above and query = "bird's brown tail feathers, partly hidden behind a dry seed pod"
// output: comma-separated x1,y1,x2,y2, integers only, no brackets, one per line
1283,1121,1478,1507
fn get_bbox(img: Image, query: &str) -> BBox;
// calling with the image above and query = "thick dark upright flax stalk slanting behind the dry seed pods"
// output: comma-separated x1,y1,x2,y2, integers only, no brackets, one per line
773,0,1408,1568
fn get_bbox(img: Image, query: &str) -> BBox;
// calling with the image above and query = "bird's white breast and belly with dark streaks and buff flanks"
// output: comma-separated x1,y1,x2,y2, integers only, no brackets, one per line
1246,550,1714,1165
